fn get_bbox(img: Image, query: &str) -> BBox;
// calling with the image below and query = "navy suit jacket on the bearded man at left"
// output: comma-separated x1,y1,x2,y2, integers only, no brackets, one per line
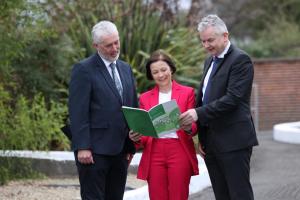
69,53,138,155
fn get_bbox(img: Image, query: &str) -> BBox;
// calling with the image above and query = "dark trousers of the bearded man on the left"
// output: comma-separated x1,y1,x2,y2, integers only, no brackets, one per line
75,153,128,200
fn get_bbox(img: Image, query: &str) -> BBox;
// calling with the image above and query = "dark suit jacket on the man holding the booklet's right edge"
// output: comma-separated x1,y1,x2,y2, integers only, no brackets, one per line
196,45,258,152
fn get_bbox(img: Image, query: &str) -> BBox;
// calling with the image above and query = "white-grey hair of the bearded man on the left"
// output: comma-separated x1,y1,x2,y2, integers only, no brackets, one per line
92,21,119,44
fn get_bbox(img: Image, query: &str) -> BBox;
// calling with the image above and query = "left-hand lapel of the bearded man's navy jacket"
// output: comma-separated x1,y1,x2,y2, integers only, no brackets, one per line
95,53,122,104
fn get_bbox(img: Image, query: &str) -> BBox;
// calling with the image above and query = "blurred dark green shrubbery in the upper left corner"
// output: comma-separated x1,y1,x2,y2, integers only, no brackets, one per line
0,0,77,100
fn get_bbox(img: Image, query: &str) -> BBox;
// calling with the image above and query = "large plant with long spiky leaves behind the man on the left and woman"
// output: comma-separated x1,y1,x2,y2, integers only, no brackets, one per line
39,0,204,92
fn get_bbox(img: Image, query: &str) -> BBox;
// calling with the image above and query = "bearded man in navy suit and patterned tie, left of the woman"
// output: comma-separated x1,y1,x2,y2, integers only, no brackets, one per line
69,21,137,200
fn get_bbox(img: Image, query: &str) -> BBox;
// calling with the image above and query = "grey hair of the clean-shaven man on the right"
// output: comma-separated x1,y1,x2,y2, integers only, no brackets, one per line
197,15,228,34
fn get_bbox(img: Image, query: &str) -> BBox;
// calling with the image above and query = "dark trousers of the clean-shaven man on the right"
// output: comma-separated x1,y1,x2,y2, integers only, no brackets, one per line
204,135,254,200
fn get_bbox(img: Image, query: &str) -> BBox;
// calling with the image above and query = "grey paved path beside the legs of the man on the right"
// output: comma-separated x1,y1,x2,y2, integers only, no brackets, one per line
189,131,300,200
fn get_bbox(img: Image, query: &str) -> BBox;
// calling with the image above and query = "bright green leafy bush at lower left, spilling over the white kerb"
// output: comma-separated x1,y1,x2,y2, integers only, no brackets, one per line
0,83,64,185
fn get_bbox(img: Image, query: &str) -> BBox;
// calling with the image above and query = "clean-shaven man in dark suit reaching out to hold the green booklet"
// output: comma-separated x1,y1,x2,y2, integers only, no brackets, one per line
180,15,258,200
